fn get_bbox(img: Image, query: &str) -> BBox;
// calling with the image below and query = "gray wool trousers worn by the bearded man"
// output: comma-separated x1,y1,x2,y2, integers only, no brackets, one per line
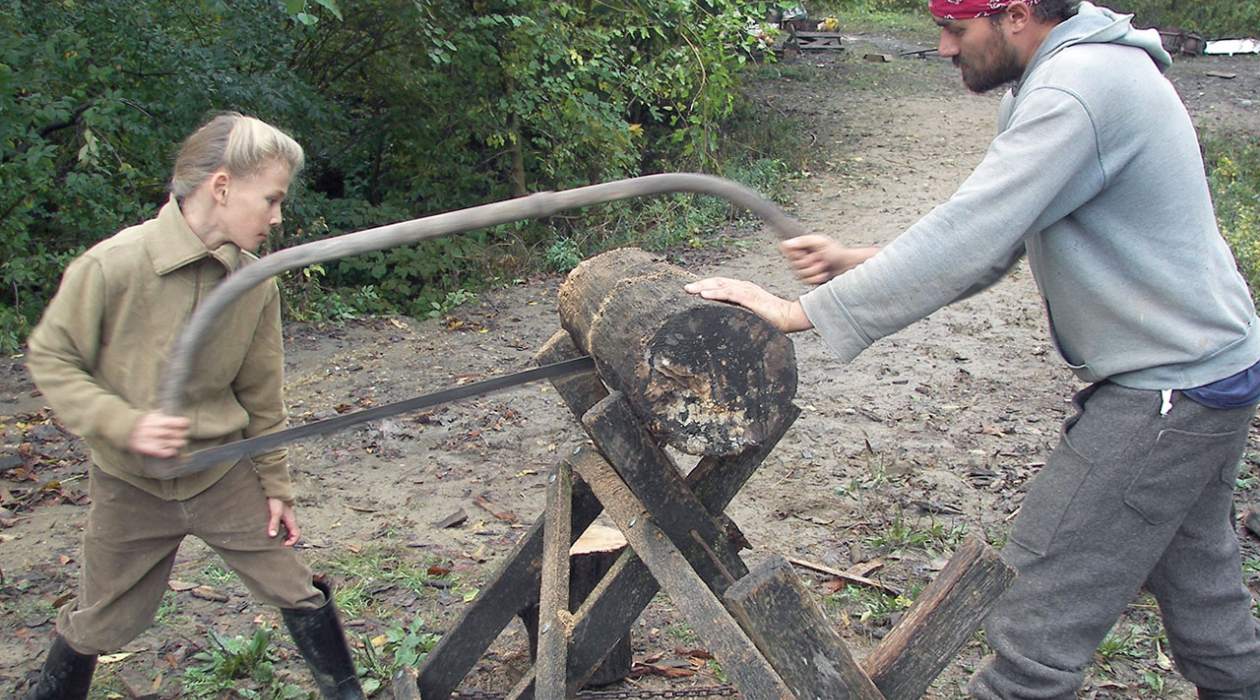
970,383,1260,700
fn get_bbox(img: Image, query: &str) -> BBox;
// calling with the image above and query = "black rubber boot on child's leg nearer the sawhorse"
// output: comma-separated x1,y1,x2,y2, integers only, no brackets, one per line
280,580,364,700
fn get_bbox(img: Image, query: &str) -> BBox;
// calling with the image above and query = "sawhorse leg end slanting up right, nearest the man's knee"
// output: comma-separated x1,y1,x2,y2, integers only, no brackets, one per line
862,539,1016,700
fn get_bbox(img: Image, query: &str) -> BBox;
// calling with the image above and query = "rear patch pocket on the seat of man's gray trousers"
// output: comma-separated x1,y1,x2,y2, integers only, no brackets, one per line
1124,429,1245,525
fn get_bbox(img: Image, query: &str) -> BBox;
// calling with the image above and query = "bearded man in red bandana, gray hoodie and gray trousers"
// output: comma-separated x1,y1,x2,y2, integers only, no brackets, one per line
687,0,1260,700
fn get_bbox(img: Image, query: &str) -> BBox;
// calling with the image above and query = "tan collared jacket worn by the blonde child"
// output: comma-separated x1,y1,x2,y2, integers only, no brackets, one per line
26,199,294,502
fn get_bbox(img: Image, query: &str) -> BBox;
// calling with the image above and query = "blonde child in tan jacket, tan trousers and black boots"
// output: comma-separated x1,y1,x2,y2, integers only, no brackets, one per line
28,113,363,699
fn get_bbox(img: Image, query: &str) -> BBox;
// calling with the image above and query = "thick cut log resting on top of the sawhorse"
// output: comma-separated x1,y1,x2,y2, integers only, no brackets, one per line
559,248,796,454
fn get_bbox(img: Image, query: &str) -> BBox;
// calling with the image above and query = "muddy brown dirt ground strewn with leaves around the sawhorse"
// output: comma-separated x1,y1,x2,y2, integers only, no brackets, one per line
0,28,1260,697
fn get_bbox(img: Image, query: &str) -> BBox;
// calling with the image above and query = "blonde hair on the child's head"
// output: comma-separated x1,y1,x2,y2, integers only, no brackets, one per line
170,112,305,200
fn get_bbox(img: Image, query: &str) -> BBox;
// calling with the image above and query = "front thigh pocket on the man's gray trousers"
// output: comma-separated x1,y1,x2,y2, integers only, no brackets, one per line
1011,442,1091,556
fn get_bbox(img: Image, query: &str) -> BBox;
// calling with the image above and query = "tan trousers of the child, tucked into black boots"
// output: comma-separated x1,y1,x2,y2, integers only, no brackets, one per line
57,460,324,653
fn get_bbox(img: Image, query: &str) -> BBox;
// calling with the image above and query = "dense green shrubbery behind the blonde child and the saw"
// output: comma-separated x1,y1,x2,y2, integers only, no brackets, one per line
0,0,796,351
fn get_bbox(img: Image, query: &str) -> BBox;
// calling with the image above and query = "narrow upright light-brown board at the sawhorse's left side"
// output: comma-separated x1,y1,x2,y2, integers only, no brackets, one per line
534,462,573,697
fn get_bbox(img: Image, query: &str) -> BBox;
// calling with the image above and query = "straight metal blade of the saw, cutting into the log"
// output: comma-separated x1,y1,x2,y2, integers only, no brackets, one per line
171,355,595,476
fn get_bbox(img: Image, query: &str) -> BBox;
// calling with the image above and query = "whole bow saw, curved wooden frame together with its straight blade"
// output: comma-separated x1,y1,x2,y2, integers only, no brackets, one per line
145,172,808,478
